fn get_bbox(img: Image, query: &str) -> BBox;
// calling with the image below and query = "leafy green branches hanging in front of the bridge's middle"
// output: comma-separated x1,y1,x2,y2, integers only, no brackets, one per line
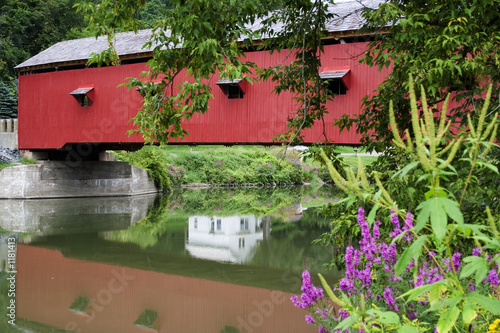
78,0,348,144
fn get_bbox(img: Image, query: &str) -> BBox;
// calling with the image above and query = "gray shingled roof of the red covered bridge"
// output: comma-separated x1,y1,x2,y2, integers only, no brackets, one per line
15,0,384,69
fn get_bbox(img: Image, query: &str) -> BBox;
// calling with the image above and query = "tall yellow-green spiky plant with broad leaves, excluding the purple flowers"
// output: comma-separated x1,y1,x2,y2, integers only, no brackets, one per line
316,77,500,332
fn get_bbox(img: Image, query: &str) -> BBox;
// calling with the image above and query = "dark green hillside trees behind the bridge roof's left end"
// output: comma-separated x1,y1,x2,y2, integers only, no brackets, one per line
0,0,168,118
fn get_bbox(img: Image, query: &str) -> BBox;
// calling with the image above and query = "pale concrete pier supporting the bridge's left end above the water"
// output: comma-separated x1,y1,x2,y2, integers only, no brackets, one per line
0,161,158,199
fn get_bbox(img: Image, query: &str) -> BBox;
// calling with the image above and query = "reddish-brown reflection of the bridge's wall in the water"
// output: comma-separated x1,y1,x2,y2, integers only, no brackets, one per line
17,244,315,333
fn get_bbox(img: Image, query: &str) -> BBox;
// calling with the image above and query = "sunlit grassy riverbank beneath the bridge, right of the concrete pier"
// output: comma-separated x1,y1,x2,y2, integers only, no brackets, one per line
115,146,329,189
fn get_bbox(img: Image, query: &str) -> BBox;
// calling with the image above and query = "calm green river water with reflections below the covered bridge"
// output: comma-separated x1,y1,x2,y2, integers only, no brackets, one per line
0,187,338,333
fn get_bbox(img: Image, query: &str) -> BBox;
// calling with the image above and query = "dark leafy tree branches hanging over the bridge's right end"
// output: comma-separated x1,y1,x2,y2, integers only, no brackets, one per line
337,0,500,151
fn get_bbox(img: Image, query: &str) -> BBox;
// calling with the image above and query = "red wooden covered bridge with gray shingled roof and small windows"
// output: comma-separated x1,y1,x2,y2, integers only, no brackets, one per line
16,1,387,157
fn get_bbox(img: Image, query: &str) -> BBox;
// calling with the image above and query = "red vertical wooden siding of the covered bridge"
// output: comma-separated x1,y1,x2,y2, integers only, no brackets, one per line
19,43,388,149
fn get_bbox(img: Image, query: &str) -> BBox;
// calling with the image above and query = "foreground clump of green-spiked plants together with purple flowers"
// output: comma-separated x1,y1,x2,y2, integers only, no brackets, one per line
292,77,500,333
